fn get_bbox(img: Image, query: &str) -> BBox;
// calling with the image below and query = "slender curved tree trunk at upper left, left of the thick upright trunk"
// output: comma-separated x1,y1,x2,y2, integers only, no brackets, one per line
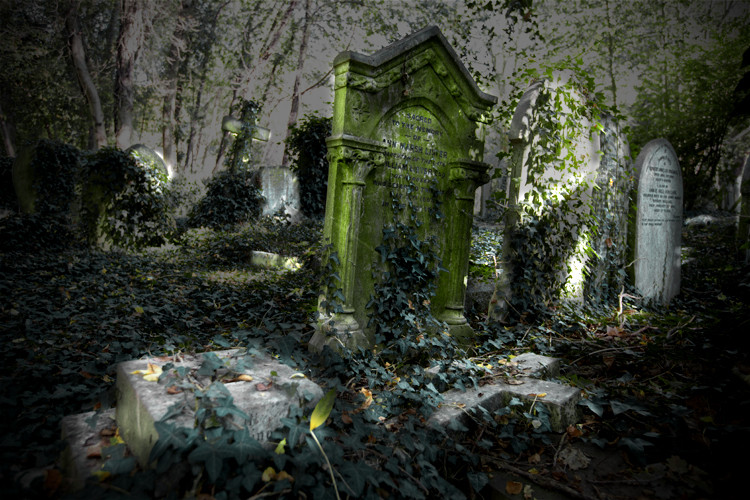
65,0,107,149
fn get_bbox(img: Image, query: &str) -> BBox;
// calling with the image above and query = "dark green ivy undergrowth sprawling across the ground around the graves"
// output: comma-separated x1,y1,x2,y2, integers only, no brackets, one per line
0,212,750,498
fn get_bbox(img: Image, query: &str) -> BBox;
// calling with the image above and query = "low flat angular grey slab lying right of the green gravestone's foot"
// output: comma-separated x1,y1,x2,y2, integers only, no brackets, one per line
429,353,581,432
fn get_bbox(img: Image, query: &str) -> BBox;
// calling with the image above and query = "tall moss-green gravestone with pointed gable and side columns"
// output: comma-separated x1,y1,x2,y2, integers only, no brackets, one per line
311,27,497,349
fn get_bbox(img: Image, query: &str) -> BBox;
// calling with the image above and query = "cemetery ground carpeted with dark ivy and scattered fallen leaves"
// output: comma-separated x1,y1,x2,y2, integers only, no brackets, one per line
0,214,750,499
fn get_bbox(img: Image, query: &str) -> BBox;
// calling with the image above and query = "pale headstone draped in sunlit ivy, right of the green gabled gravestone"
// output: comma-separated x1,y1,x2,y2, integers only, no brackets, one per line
488,73,630,321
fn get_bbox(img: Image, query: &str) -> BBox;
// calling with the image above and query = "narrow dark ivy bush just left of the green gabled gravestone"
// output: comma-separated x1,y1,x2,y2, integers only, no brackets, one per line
286,114,331,217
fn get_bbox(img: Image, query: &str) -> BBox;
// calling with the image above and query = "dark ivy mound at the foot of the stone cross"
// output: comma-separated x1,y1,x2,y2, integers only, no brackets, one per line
189,166,264,229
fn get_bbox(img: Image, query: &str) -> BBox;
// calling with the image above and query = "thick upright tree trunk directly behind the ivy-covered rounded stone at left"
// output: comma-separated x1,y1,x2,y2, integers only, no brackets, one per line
115,0,143,149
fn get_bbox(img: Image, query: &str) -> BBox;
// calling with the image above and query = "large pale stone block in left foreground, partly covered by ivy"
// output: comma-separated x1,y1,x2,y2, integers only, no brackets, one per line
116,349,323,467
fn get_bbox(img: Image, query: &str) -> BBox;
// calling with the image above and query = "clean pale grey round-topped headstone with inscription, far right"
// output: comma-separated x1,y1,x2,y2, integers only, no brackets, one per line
629,139,682,305
